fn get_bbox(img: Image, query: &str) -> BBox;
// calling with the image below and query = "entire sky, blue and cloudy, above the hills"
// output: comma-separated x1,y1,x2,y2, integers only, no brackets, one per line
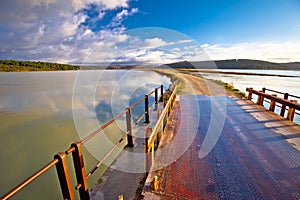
0,0,300,63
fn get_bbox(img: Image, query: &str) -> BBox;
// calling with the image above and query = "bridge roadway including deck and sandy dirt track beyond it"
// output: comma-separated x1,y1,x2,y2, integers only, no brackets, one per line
143,74,300,200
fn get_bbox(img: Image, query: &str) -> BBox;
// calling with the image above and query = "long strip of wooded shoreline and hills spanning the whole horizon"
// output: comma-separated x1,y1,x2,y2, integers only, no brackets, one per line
0,59,300,72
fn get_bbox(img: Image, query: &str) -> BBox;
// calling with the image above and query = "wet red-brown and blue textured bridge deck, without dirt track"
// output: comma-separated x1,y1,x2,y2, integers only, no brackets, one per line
145,95,300,200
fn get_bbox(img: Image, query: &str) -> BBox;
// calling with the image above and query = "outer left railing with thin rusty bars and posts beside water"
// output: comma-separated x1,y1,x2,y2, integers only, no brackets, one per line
0,85,164,200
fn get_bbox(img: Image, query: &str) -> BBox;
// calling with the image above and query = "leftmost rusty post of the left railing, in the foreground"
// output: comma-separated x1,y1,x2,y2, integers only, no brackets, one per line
54,152,75,200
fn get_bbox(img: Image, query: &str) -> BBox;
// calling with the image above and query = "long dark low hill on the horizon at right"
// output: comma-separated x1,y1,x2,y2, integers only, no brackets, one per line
161,59,300,70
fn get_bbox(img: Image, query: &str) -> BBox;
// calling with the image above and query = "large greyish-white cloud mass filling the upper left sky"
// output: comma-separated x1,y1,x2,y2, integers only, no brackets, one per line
0,0,134,62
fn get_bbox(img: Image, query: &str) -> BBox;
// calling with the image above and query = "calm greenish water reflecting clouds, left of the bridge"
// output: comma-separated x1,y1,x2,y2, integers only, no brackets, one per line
0,70,170,199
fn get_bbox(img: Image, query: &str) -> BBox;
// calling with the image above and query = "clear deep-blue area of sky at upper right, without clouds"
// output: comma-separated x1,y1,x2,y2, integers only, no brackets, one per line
125,0,300,43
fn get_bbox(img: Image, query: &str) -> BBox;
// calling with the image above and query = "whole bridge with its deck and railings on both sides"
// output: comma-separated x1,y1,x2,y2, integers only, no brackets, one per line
0,74,300,199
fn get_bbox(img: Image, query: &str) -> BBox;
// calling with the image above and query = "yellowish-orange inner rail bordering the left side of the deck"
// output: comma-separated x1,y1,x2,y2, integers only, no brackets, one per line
145,86,177,172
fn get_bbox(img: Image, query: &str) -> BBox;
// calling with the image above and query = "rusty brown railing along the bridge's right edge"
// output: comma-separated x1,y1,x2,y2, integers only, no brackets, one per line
246,88,300,121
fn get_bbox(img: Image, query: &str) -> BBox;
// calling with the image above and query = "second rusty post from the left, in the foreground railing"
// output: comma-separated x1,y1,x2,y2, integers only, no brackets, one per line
71,142,90,200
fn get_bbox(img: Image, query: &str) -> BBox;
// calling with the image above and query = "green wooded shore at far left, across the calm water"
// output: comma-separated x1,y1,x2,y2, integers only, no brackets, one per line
0,60,80,72
